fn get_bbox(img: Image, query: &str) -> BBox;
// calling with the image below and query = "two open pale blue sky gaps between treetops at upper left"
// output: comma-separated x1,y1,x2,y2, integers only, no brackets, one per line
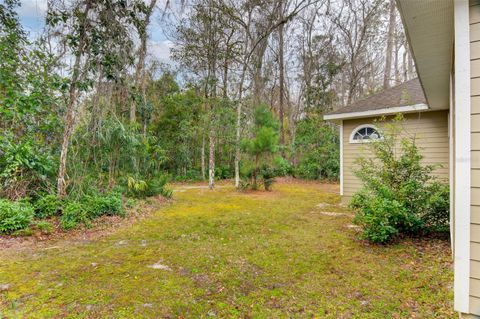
17,0,173,64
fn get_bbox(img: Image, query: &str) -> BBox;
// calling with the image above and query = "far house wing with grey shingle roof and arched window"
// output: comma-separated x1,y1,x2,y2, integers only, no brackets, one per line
324,79,449,203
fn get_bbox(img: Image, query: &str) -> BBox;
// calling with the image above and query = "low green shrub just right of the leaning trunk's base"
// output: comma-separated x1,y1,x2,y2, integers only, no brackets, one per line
81,192,125,219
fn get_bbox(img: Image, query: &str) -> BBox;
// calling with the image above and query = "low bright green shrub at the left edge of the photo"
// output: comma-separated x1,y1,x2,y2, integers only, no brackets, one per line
0,199,34,234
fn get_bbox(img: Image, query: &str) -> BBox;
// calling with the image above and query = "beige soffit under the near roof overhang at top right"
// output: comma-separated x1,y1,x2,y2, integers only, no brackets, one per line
397,0,454,110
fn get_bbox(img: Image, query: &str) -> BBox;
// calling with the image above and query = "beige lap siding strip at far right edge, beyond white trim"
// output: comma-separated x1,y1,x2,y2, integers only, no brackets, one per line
470,1,480,308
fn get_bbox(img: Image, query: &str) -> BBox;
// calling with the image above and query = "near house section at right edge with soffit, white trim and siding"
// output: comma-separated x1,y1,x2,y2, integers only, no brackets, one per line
326,0,480,319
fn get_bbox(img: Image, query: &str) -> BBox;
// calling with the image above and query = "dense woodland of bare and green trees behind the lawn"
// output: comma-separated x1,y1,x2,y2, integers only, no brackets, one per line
0,0,415,232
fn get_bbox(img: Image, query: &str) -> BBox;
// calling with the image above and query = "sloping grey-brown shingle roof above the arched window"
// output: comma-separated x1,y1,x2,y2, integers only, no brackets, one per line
327,78,427,115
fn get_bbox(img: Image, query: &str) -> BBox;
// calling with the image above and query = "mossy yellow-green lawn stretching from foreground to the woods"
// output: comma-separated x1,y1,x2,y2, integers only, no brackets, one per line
0,182,455,319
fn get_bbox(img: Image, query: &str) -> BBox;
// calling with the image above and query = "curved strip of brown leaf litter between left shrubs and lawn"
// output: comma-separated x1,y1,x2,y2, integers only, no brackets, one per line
0,196,169,254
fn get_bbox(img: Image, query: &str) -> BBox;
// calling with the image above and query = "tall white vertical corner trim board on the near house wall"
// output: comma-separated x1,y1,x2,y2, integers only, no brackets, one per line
454,0,471,313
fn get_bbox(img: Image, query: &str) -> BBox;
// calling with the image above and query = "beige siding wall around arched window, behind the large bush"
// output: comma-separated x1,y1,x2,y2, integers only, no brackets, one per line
342,111,450,202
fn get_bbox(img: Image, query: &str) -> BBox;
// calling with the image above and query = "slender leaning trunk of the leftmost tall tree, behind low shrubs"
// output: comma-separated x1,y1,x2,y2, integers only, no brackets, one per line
57,1,91,198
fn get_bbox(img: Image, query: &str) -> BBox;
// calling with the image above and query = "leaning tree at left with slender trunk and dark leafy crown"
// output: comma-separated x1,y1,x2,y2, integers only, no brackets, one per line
47,0,139,197
